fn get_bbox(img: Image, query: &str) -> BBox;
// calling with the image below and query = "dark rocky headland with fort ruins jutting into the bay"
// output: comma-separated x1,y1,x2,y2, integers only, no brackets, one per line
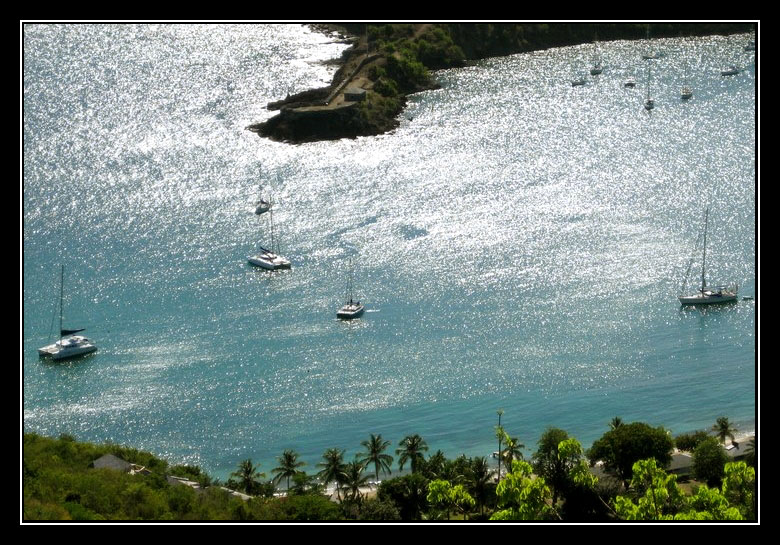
247,23,755,143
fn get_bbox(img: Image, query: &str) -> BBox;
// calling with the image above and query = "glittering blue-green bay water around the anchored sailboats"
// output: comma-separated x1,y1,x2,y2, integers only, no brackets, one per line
20,24,758,479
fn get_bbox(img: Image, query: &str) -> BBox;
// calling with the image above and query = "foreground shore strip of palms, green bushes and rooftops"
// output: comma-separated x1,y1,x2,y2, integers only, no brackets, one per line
22,417,758,522
